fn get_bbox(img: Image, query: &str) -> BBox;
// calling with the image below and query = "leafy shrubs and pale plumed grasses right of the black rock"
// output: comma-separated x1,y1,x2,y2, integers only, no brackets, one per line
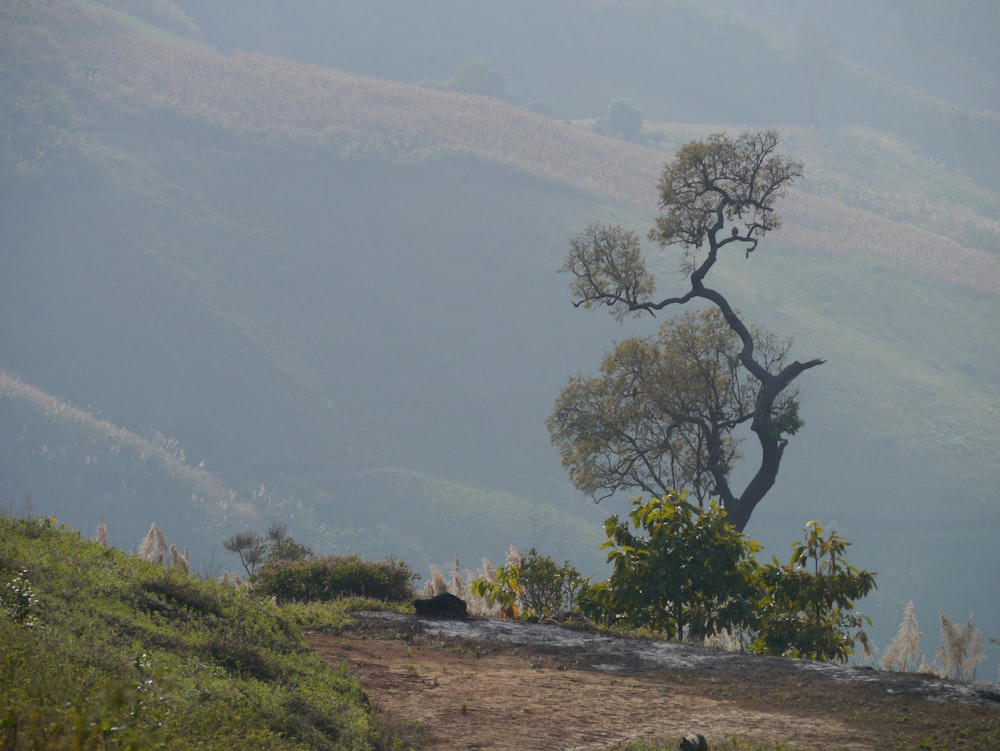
462,494,1000,682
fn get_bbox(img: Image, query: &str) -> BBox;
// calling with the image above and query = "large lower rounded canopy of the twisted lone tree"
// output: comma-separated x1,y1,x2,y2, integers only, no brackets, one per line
547,308,802,503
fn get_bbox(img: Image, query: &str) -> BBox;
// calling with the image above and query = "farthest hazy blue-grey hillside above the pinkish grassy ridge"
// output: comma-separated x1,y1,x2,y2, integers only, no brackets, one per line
184,0,1000,189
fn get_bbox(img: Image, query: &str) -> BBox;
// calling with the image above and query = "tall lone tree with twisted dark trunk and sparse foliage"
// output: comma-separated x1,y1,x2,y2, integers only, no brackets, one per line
548,130,824,531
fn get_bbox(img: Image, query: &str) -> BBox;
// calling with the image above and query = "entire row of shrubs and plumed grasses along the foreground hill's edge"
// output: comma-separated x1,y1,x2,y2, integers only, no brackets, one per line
62,500,985,681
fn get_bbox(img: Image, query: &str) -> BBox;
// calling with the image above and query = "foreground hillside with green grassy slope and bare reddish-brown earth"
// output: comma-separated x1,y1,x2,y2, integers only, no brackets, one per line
0,508,1000,751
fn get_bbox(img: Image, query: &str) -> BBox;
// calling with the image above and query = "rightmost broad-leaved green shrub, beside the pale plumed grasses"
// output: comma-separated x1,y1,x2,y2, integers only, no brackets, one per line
752,521,875,662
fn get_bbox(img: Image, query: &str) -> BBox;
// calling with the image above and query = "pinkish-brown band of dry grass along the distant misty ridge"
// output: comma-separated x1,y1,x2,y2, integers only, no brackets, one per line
17,0,1000,294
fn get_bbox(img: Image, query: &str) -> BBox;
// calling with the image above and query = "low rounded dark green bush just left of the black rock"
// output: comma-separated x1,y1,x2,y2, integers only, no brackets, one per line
252,555,416,602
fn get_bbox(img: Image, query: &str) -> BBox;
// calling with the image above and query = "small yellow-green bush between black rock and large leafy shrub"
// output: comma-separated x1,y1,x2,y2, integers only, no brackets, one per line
471,548,583,618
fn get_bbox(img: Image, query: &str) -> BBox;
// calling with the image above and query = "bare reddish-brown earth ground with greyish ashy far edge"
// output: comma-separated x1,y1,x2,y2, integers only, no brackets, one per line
309,614,1000,751
